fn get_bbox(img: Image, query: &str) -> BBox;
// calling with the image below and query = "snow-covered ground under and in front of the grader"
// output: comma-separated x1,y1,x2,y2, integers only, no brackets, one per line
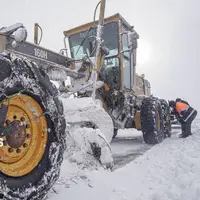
48,114,200,200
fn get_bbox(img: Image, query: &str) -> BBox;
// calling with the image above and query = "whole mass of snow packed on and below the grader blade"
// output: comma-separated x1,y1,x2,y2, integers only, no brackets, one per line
61,98,113,169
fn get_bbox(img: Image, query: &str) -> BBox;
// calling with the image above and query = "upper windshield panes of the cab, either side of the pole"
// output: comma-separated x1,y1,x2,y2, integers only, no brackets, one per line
69,22,118,59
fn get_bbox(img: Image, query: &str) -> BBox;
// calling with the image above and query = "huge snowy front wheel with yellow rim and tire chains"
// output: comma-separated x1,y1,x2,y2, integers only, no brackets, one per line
0,54,66,200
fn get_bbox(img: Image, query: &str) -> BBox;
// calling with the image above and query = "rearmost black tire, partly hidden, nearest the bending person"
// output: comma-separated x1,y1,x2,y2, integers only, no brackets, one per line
160,99,172,138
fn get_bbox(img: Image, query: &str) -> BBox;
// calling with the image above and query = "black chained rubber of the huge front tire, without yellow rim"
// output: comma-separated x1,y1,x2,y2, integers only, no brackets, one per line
0,54,66,200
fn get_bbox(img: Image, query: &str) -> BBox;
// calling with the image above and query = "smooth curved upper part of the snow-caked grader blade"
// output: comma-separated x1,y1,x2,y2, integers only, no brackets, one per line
61,97,113,143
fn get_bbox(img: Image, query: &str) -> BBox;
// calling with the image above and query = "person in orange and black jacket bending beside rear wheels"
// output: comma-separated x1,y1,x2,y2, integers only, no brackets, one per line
169,101,197,138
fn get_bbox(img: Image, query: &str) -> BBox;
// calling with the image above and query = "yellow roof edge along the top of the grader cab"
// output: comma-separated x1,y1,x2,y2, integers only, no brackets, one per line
63,13,134,37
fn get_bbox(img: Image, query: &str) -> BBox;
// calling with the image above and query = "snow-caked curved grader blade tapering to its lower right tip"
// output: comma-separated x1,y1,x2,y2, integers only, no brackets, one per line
62,97,114,167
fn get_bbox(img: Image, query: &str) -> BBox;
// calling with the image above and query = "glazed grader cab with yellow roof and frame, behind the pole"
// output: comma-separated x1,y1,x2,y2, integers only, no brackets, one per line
64,14,139,90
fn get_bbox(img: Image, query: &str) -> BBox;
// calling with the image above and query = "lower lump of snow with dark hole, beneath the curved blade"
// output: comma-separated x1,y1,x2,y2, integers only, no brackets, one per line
65,128,113,169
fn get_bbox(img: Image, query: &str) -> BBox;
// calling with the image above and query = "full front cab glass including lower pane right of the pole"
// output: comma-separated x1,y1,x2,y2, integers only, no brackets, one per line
69,22,120,89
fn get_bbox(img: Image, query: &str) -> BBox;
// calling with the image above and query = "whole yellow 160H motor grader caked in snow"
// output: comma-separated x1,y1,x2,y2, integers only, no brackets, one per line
0,0,170,200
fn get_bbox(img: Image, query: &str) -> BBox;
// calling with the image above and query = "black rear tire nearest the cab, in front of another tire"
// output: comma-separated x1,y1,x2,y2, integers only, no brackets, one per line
141,97,164,144
